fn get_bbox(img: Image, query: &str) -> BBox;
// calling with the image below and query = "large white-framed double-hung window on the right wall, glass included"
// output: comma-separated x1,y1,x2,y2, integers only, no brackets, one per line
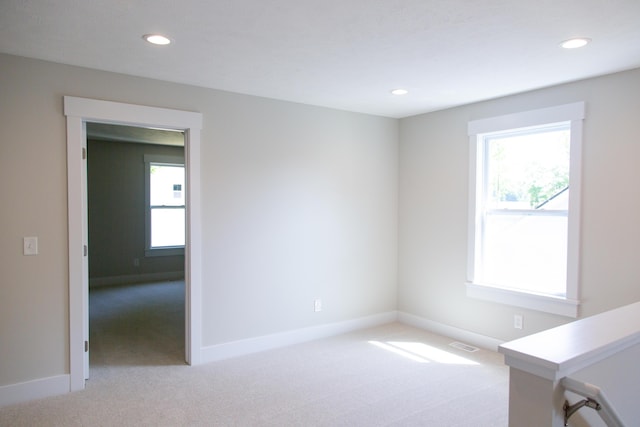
467,103,584,317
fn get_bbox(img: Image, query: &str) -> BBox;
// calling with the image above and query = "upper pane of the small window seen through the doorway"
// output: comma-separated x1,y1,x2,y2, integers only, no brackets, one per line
149,163,185,206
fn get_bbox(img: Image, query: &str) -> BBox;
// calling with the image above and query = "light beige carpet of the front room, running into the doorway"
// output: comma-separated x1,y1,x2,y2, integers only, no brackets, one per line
0,283,508,427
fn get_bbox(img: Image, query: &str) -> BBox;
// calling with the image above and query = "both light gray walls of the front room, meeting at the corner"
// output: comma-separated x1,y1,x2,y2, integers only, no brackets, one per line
0,50,640,392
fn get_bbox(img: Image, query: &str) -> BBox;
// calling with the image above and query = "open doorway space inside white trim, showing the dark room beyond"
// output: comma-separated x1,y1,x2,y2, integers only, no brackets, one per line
86,122,186,372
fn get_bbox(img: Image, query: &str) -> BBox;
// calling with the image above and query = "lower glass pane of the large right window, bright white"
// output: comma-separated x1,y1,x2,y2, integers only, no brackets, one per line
482,215,567,296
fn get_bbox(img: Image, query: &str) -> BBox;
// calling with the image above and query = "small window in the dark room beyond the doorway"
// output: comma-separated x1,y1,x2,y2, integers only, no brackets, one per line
144,155,185,256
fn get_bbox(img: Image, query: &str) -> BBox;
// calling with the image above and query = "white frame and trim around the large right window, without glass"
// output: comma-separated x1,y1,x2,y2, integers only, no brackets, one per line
466,102,585,318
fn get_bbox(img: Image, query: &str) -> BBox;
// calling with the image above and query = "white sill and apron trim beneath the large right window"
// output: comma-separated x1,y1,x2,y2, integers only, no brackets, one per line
466,282,580,319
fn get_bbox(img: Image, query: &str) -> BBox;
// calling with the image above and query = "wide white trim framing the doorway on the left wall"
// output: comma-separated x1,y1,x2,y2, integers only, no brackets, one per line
64,96,202,391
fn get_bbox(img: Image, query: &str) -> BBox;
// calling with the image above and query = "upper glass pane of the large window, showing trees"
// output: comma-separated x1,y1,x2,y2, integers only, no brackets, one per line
485,125,570,209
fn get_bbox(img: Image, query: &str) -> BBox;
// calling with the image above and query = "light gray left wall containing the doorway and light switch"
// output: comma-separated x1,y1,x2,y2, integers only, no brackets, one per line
0,55,398,386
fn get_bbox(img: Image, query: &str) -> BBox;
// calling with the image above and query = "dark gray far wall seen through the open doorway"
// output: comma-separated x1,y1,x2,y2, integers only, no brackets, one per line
87,140,184,286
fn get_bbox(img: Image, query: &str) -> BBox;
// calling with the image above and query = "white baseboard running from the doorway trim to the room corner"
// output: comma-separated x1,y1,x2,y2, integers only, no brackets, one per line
201,311,397,363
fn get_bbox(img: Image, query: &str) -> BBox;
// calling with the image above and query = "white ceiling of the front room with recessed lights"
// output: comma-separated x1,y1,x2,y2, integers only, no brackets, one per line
0,0,640,117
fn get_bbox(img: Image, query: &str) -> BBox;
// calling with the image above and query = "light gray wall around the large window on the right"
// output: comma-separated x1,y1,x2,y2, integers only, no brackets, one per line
398,69,640,341
